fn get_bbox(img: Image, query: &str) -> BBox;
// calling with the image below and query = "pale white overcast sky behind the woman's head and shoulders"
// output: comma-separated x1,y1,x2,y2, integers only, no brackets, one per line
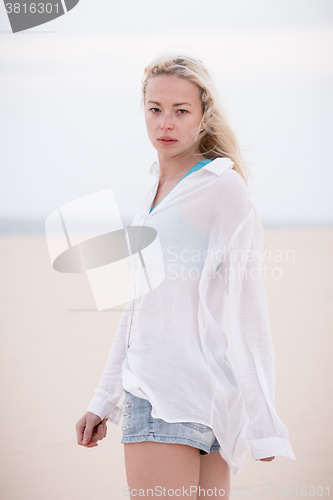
0,0,333,232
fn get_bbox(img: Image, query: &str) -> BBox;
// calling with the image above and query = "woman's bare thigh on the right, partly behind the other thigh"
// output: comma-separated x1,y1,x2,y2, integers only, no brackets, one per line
198,451,230,499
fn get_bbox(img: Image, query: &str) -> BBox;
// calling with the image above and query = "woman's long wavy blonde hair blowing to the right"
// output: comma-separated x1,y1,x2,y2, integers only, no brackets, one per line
141,53,252,187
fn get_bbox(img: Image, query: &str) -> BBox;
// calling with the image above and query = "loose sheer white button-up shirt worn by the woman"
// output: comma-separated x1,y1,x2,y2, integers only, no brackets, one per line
88,158,296,475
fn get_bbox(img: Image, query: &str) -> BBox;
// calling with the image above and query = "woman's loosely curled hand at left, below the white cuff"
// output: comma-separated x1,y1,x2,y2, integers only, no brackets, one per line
75,411,107,448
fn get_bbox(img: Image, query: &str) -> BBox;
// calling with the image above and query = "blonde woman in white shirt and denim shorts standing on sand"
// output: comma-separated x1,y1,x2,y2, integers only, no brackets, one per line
76,55,296,498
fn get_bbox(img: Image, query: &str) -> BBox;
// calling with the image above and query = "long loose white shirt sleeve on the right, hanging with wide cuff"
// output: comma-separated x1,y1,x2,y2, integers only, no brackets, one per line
223,202,296,460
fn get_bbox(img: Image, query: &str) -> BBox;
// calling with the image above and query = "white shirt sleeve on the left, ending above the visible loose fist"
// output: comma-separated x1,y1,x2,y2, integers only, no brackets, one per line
87,301,133,424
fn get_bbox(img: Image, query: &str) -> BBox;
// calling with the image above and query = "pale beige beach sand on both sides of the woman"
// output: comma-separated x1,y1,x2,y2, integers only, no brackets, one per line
0,228,333,500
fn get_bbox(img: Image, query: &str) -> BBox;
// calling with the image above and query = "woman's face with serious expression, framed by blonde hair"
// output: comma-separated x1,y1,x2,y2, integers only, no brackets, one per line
145,75,202,159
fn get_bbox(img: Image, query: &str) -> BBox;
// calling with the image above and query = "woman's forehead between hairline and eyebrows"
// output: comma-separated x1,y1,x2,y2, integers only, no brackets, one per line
146,75,199,102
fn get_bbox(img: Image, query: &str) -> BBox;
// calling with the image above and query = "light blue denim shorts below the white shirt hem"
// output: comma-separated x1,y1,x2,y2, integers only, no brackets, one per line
121,389,220,455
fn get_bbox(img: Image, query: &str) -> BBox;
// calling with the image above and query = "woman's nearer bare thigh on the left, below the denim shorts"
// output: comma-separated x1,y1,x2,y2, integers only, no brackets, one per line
124,441,198,500
